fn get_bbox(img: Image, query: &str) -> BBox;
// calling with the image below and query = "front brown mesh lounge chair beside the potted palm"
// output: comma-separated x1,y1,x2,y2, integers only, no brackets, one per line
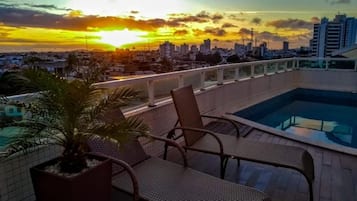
88,108,270,201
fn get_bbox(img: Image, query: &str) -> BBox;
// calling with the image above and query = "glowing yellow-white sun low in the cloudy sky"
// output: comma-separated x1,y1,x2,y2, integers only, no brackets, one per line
98,29,147,47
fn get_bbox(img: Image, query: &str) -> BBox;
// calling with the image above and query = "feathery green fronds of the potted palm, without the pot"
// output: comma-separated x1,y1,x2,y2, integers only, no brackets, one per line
0,70,149,173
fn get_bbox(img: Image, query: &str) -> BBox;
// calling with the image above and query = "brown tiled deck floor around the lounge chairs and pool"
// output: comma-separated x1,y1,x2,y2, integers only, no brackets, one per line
113,122,357,201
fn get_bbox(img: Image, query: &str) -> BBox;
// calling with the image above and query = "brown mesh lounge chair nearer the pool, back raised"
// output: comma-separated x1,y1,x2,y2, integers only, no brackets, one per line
164,86,314,201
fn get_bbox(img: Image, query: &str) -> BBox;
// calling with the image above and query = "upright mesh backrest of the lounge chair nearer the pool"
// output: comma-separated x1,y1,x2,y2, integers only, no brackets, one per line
171,85,205,146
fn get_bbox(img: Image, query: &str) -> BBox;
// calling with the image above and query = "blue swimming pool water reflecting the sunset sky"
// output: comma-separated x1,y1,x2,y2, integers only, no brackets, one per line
235,88,357,148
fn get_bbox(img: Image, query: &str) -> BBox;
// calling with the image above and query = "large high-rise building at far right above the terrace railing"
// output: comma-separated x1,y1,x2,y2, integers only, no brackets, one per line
310,15,357,57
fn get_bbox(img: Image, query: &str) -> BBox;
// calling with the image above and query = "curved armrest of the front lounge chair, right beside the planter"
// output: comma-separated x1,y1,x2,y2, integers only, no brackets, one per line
90,152,139,201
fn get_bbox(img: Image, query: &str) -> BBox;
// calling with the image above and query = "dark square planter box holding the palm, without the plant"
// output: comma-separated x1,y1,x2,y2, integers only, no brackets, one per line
30,155,112,201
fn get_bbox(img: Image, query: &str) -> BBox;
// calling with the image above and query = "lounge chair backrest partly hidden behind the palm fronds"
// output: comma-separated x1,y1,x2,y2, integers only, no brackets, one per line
88,109,149,166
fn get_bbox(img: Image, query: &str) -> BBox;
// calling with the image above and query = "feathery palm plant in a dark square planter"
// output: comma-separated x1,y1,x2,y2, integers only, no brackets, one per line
0,70,148,201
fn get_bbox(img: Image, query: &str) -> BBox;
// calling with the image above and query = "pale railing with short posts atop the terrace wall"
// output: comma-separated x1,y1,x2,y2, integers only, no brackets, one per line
4,57,357,106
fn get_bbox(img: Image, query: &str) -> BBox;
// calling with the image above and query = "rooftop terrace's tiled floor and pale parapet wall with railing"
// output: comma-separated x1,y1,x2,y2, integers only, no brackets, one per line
0,58,357,201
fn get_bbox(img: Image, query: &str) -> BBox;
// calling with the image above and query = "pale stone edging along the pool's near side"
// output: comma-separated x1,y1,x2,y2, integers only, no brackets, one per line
223,113,357,156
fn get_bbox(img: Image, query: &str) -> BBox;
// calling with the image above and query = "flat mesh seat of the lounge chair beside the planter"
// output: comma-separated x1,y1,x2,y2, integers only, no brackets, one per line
112,157,270,201
